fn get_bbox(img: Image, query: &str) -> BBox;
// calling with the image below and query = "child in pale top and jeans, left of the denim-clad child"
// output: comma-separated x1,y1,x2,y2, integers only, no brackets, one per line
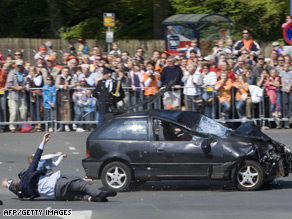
72,83,86,132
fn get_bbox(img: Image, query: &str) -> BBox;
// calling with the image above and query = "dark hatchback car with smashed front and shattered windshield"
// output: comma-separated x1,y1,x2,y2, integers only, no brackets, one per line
82,110,292,191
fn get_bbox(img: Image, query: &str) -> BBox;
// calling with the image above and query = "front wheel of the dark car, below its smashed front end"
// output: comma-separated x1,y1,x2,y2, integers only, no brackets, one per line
234,160,264,191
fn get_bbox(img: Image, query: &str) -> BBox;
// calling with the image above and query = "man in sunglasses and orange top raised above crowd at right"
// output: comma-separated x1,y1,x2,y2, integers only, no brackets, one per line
233,29,261,56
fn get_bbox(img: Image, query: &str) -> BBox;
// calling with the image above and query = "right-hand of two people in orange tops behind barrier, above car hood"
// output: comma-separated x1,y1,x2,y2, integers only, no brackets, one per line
233,75,248,122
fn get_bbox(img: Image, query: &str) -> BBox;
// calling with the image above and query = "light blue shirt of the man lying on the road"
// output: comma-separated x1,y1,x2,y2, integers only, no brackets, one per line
38,171,61,198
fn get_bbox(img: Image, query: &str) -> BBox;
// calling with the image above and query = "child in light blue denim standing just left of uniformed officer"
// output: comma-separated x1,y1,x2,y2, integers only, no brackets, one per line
83,89,96,131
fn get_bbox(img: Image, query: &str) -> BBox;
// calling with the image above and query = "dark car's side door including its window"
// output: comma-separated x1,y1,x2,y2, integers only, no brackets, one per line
150,119,221,178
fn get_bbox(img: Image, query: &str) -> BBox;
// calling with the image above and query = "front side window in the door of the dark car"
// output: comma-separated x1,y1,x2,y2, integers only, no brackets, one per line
153,119,192,141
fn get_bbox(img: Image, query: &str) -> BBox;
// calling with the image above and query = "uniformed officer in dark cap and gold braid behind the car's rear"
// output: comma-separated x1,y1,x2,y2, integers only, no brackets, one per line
93,68,125,125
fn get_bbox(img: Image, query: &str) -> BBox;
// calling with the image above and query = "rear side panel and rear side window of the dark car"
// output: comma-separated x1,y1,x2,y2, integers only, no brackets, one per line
93,117,150,178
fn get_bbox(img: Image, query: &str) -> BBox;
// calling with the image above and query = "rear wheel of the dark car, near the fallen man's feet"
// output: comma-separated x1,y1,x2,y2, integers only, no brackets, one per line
101,162,132,192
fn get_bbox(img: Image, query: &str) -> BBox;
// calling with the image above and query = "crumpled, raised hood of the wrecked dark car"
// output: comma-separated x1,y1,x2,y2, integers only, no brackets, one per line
226,122,272,141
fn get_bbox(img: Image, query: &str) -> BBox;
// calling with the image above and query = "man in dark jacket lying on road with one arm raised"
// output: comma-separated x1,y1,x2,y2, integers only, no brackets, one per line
2,133,116,202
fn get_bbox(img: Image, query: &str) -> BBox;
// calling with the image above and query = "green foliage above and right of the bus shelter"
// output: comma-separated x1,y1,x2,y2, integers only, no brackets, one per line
169,0,290,41
